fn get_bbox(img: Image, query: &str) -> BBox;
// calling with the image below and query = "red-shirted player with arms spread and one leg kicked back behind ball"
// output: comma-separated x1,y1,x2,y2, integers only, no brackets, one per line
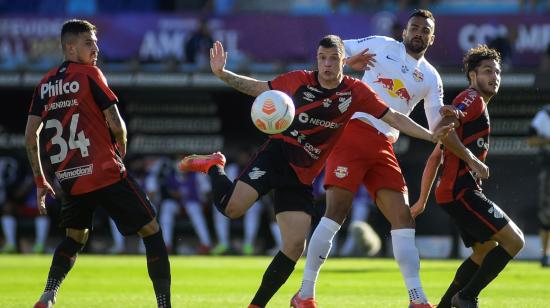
180,35,452,307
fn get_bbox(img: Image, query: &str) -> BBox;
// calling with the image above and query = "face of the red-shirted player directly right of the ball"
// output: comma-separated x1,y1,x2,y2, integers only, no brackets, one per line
317,46,344,87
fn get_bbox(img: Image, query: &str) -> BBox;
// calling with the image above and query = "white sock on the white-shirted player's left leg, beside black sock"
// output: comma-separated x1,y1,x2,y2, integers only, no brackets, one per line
300,217,340,298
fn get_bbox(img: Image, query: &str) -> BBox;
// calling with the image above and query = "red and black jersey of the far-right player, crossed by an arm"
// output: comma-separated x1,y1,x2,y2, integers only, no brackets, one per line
435,88,490,203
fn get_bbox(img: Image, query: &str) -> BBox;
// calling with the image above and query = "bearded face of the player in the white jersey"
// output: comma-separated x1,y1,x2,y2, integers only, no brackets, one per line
403,16,435,54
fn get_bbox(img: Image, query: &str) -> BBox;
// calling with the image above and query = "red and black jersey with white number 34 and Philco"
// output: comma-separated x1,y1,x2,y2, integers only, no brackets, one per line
29,62,126,195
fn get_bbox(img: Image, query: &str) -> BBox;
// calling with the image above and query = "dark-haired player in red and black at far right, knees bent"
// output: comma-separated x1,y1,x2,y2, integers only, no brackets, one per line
413,45,524,308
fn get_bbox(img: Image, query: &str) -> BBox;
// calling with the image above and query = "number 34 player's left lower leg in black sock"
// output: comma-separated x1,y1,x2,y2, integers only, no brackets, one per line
34,229,89,308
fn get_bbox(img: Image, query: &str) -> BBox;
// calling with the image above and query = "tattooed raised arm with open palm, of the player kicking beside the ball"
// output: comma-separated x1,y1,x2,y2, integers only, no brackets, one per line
210,41,269,97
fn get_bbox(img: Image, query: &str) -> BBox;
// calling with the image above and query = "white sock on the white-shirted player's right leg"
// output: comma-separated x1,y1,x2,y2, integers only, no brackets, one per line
391,229,428,303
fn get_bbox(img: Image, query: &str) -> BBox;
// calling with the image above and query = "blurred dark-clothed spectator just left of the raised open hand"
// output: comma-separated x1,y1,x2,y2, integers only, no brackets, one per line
185,19,214,66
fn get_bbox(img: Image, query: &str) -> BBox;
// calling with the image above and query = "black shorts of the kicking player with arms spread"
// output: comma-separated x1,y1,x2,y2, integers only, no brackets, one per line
237,140,313,215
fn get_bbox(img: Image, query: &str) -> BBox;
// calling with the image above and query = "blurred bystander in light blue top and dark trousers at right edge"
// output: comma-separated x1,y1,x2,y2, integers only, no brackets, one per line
527,105,550,267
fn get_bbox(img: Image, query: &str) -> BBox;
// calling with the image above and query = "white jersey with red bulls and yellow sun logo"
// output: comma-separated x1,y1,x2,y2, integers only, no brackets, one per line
344,36,443,143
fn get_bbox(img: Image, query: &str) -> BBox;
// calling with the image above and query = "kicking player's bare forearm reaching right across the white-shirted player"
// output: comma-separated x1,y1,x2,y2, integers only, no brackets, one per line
381,108,454,143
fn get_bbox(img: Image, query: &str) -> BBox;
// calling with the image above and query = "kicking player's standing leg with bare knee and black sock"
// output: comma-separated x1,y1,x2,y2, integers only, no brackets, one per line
249,211,311,307
